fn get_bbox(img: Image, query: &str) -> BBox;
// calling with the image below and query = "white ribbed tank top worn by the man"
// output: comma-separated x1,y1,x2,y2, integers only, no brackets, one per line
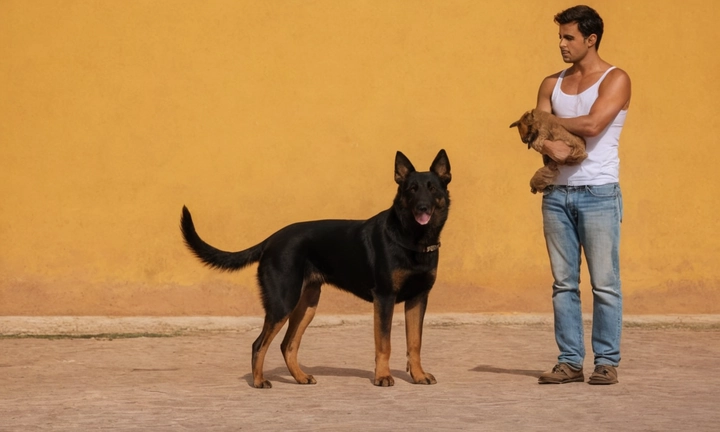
550,66,627,186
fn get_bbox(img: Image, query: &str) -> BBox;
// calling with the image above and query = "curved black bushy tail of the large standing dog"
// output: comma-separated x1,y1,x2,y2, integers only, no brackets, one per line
180,206,262,271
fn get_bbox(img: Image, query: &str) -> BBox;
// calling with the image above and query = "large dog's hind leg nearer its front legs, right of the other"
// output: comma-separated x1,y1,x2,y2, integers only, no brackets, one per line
280,282,321,384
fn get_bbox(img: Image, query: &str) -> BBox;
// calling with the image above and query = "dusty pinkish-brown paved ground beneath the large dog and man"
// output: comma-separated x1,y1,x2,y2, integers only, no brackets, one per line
0,315,720,431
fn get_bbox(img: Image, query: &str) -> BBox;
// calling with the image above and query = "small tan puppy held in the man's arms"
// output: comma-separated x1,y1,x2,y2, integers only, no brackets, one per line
510,109,587,193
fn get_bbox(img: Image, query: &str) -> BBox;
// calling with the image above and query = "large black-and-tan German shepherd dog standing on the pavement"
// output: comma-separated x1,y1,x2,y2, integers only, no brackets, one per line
181,150,452,388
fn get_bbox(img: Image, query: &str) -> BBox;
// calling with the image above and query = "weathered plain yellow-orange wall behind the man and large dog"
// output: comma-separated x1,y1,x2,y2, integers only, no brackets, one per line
0,0,720,315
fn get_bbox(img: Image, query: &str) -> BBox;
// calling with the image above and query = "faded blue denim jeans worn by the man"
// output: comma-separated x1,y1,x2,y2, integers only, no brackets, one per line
542,183,623,367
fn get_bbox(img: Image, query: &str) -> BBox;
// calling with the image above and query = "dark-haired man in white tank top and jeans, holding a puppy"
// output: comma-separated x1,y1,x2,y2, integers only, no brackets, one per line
537,6,630,384
